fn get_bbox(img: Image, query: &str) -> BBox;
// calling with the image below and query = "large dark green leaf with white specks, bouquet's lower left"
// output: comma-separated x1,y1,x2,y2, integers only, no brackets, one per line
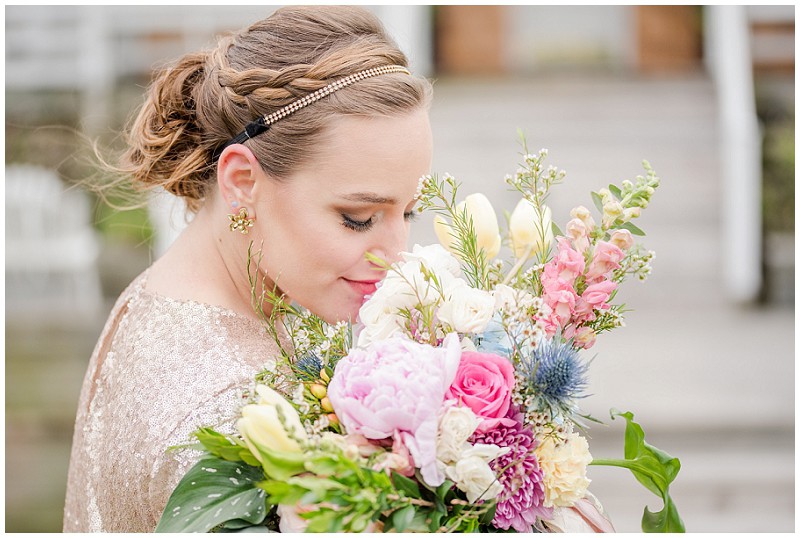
156,456,267,532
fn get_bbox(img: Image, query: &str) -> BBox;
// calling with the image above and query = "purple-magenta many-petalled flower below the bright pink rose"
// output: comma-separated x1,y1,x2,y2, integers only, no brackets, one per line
470,413,553,532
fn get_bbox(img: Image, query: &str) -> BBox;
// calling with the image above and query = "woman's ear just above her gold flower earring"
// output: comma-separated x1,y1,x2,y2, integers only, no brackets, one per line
217,144,264,216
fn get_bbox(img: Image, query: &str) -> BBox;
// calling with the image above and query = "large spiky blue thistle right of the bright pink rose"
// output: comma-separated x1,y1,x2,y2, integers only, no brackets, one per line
519,338,589,414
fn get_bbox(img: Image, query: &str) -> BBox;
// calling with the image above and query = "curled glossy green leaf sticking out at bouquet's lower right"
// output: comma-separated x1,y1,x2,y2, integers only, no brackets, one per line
592,410,686,532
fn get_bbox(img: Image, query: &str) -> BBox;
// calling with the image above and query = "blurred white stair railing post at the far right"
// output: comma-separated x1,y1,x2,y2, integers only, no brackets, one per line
705,5,762,303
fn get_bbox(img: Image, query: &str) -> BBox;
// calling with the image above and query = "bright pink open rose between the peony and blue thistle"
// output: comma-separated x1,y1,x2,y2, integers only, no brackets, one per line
447,351,514,432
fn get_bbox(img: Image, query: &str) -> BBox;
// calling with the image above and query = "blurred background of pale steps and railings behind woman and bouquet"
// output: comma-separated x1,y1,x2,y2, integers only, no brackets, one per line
5,5,795,532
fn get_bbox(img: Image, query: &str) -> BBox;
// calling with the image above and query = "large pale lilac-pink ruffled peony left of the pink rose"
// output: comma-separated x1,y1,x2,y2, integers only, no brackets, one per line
328,334,461,486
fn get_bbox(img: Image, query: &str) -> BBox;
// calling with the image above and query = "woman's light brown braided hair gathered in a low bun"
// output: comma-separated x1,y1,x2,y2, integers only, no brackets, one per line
122,6,431,212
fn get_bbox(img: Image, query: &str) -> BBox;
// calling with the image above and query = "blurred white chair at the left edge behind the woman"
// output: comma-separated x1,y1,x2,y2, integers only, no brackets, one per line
5,165,103,321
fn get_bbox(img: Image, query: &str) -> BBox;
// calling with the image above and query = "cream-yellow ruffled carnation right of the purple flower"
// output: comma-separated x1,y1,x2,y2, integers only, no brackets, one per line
536,432,592,508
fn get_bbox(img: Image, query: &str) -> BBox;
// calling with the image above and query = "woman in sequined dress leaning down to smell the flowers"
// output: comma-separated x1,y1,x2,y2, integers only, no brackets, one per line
64,7,431,532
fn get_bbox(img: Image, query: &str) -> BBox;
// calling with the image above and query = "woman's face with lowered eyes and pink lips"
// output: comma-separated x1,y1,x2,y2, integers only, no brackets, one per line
253,110,431,322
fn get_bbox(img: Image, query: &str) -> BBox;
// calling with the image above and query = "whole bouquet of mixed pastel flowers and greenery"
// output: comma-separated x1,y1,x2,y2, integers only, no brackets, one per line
157,144,683,532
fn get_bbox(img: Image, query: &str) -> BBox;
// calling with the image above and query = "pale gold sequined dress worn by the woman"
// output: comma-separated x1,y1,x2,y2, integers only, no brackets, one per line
64,271,278,532
